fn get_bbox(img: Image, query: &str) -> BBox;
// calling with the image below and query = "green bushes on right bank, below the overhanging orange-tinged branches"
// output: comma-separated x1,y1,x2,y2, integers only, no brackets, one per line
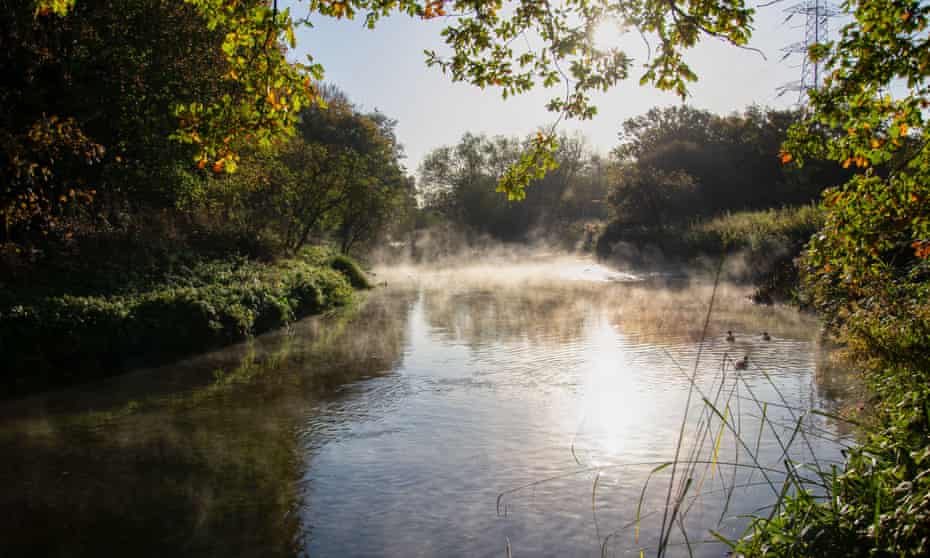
738,172,930,557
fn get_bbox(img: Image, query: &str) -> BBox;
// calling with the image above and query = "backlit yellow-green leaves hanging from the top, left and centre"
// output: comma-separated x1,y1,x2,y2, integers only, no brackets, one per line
27,0,753,199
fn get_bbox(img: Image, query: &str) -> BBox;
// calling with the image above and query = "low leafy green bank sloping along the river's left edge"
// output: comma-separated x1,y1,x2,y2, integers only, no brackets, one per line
0,250,368,397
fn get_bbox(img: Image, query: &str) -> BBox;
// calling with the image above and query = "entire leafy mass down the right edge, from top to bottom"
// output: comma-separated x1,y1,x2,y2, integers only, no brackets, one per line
738,0,930,556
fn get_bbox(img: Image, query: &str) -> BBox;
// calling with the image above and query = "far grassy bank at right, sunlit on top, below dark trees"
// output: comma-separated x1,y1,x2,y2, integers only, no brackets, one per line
597,205,823,301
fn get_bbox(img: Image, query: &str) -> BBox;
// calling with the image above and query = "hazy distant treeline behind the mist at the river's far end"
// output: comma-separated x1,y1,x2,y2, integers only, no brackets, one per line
418,106,852,252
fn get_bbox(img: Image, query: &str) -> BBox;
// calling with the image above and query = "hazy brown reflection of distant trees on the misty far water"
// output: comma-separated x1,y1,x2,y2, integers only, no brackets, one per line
424,281,818,345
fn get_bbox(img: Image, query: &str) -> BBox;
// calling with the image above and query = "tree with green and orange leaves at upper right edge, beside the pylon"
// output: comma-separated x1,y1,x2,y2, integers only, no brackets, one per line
782,0,930,370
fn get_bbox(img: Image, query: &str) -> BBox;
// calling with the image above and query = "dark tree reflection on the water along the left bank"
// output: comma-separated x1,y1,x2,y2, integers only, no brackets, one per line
0,294,411,556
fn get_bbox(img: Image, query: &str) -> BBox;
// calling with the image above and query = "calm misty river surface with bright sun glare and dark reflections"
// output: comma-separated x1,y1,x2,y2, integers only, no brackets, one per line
0,258,850,557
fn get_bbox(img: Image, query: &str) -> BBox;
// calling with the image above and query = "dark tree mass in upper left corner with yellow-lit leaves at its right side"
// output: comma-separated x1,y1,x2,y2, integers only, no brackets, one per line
0,0,312,245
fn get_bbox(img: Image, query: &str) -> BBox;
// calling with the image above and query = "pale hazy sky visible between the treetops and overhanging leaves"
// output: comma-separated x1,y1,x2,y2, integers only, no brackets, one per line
294,3,803,172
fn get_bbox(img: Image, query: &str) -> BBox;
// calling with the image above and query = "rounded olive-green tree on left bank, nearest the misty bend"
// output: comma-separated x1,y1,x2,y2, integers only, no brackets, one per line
205,93,413,253
